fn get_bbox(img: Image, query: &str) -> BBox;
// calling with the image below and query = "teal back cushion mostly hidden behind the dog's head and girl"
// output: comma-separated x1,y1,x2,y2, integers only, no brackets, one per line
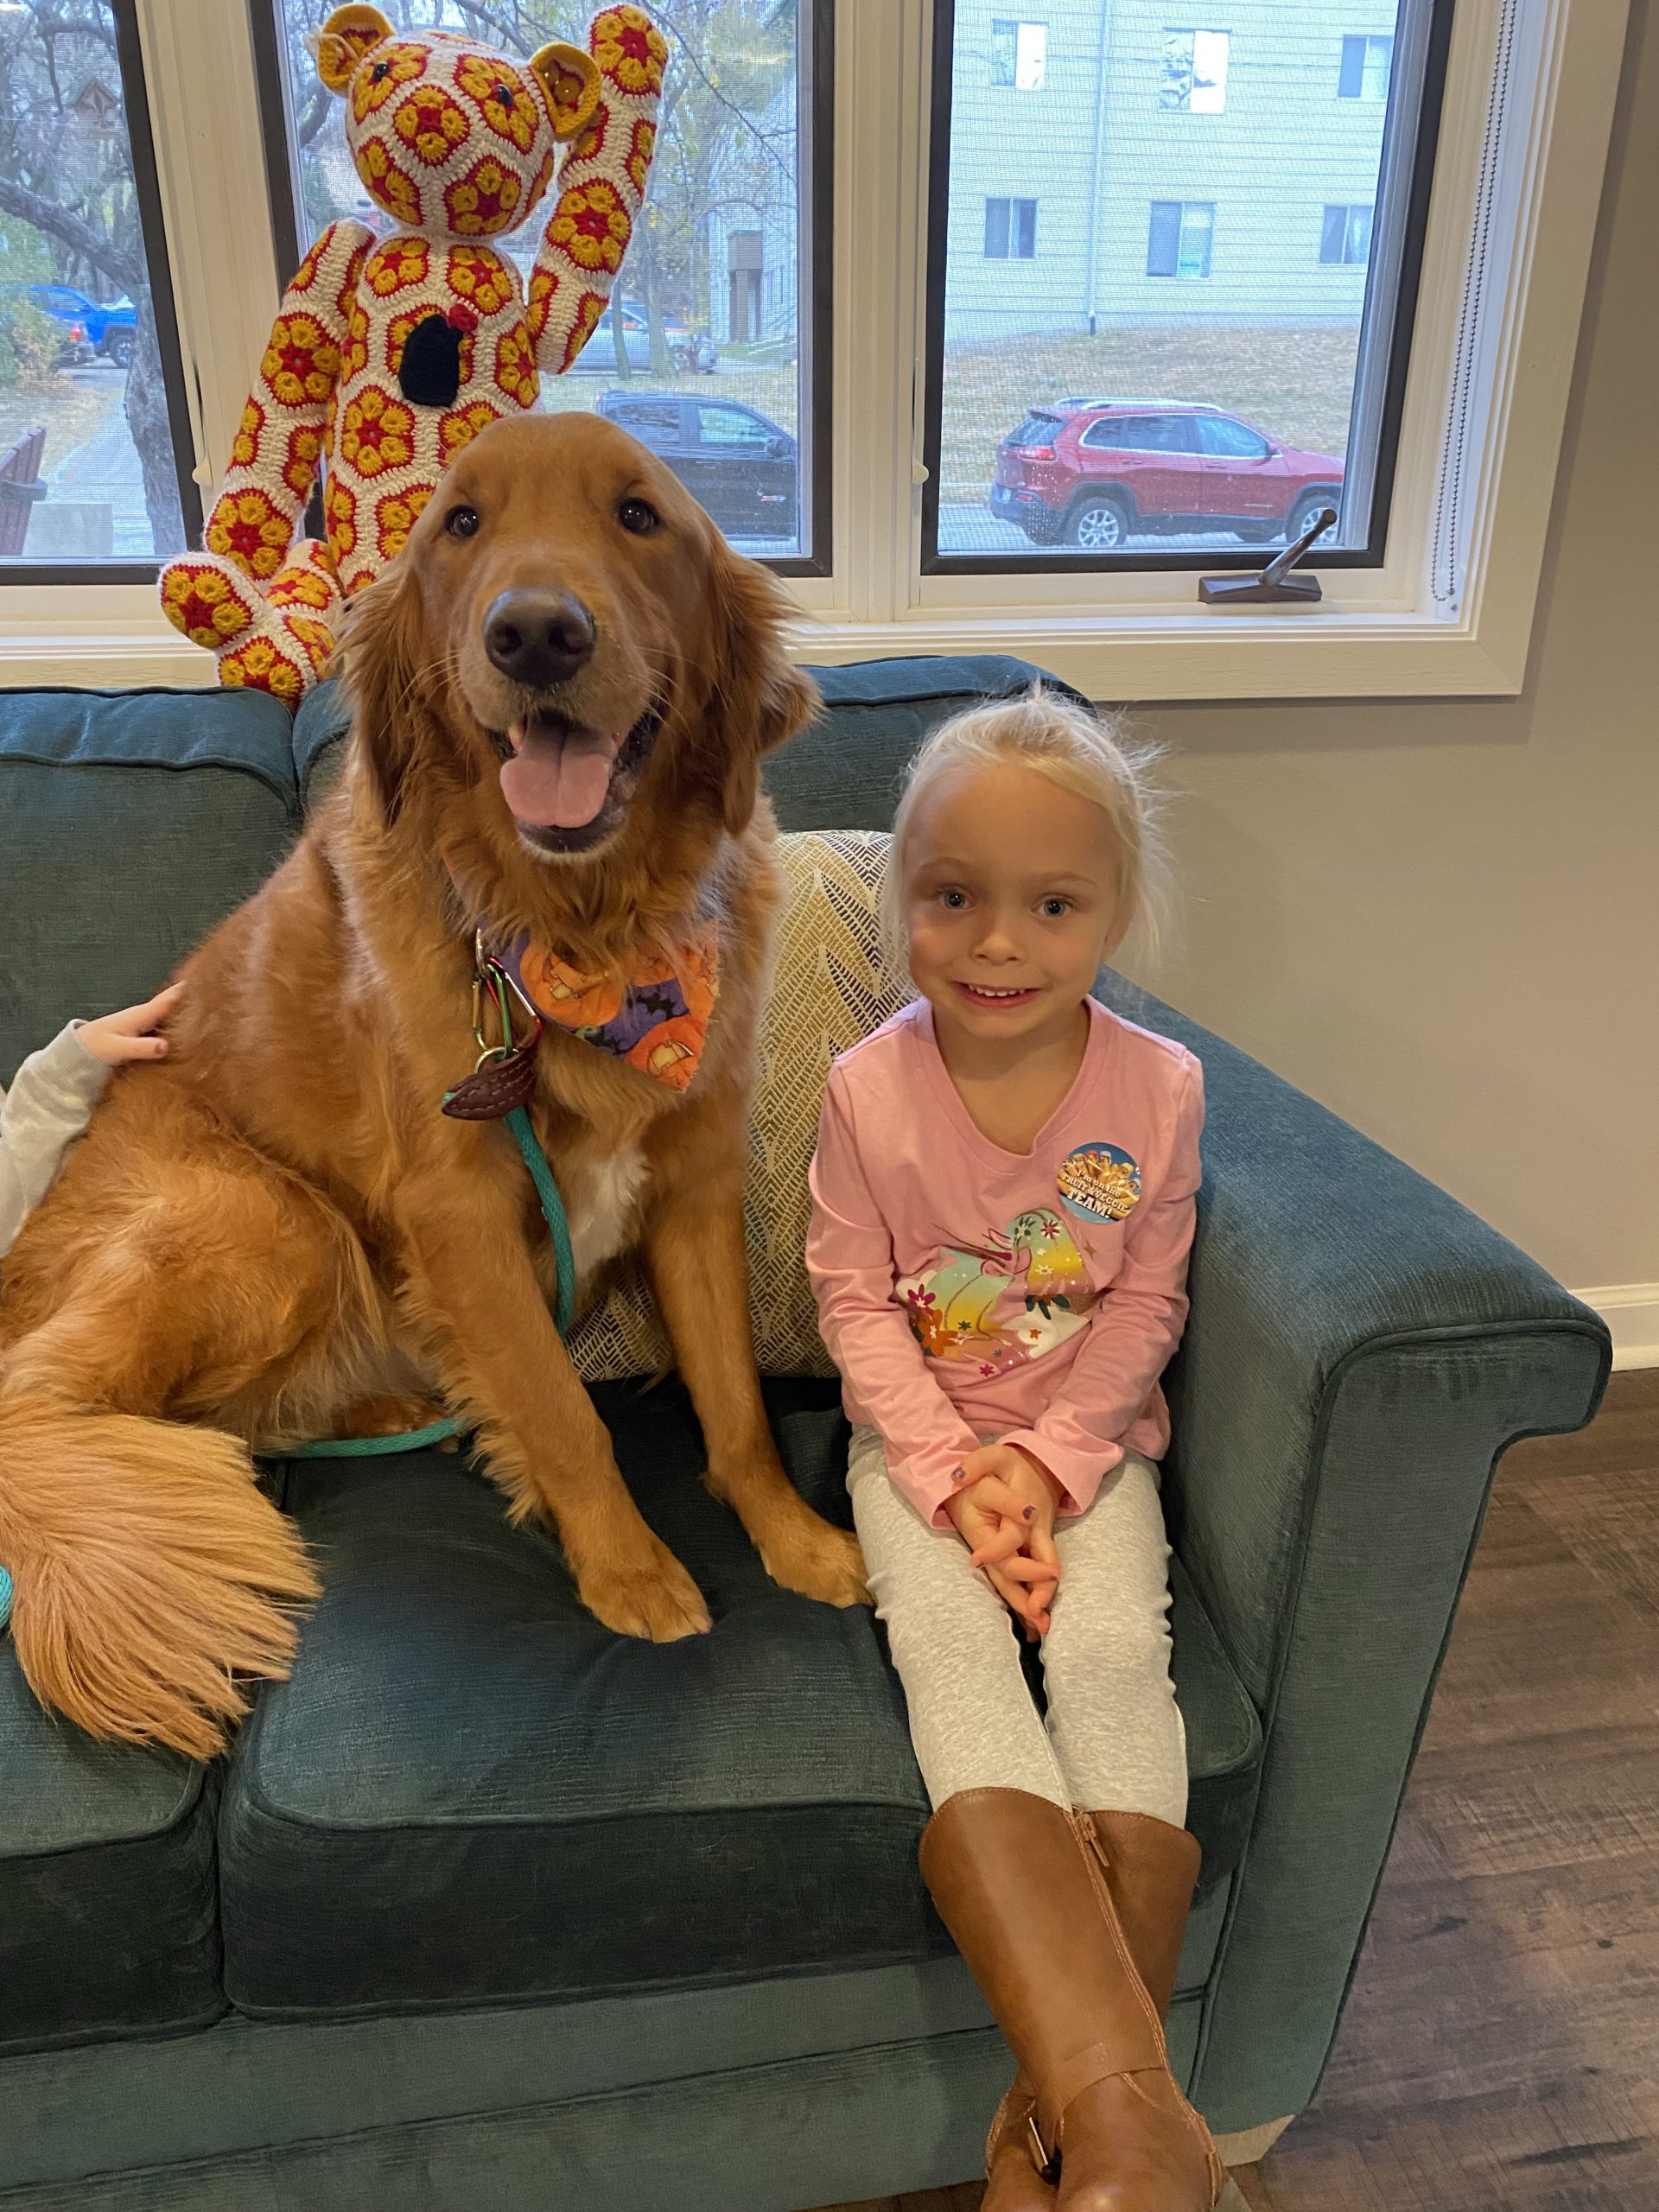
292,652,1082,830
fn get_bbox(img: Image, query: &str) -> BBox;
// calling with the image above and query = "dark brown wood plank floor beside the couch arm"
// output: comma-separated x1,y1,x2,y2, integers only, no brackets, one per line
818,1371,1659,2212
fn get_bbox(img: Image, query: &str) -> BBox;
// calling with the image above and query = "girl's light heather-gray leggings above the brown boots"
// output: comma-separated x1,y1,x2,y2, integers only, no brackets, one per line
847,1429,1185,1827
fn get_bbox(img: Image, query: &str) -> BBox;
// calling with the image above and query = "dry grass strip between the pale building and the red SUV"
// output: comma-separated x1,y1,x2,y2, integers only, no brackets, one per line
940,323,1360,500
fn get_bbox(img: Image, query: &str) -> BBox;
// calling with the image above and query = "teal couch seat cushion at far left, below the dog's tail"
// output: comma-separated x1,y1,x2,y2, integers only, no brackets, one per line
0,1637,224,2052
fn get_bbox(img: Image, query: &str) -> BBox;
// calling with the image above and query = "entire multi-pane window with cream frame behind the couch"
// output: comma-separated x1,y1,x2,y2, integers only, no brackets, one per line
0,0,1626,699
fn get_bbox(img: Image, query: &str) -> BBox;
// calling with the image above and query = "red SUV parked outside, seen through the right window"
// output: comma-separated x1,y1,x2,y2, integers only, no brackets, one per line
991,400,1343,553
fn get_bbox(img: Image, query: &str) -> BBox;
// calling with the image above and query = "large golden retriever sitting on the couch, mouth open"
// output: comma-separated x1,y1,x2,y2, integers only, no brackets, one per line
0,416,865,1757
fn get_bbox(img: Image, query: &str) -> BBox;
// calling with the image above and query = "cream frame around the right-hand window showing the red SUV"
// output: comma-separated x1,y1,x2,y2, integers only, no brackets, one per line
827,0,1626,702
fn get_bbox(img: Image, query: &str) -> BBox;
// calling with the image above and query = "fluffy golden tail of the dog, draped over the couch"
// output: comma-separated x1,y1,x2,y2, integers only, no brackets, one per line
0,1389,319,1758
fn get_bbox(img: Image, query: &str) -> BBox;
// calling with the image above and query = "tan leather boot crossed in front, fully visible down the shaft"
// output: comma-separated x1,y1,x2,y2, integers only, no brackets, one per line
920,1789,1225,2212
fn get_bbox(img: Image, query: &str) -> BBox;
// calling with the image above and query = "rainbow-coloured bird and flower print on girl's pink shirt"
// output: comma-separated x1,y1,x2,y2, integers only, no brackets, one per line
893,1205,1097,1376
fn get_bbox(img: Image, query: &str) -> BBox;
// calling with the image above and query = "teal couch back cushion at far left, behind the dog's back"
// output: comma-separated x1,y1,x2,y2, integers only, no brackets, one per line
0,690,299,1084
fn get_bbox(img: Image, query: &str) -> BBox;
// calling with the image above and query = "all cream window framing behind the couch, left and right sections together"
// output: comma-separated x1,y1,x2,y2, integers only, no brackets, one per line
0,0,1626,702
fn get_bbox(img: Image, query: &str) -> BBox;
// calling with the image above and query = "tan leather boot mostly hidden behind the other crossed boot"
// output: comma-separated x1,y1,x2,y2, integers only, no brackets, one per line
982,1812,1204,2212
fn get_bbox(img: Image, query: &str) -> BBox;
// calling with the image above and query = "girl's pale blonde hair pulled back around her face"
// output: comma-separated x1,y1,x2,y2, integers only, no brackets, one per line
880,683,1170,964
